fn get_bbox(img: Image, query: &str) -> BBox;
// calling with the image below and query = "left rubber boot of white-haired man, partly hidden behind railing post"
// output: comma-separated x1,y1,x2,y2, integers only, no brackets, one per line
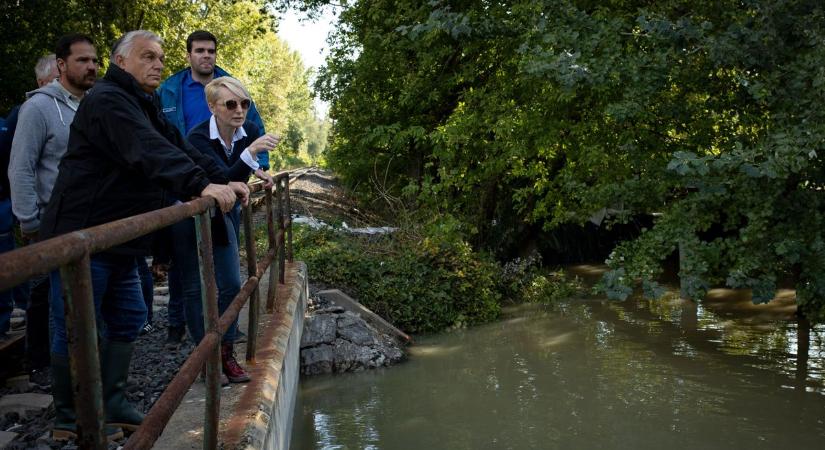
51,353,123,441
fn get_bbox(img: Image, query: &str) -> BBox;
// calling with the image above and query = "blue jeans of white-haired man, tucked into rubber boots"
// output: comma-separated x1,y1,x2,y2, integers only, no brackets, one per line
49,254,146,356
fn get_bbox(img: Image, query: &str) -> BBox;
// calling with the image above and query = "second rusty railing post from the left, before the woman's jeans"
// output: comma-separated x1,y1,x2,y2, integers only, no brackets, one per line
195,208,223,450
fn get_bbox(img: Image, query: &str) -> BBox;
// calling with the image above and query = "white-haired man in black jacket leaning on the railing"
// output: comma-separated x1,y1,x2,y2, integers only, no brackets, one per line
41,30,249,439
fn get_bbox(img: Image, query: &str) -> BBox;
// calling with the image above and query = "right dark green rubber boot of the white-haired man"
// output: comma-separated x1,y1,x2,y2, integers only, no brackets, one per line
100,341,143,432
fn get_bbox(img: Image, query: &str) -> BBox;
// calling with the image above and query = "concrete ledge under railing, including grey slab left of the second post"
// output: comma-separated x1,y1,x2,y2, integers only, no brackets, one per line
154,261,308,450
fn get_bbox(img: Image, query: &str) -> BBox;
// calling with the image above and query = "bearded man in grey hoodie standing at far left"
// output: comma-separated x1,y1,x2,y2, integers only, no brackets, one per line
9,34,98,369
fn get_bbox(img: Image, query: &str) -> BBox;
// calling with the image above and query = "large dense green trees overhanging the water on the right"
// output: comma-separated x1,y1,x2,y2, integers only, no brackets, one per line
292,0,825,319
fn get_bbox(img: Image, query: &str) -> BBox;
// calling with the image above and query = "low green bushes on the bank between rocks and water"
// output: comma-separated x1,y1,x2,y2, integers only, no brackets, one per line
295,227,500,333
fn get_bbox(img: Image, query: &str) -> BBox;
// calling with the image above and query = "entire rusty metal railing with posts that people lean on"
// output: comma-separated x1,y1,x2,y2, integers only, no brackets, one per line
0,172,292,449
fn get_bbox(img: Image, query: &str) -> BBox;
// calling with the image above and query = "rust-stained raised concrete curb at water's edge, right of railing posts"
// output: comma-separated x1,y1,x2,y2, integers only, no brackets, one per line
220,262,309,449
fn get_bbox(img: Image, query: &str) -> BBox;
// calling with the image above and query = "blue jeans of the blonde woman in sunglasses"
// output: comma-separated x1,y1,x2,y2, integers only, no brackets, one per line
169,214,241,343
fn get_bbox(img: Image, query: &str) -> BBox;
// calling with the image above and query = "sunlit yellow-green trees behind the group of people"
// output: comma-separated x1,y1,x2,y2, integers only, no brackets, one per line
0,0,326,167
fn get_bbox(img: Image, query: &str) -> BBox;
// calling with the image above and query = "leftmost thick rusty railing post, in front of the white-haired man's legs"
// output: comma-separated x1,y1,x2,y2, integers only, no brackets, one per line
60,252,108,449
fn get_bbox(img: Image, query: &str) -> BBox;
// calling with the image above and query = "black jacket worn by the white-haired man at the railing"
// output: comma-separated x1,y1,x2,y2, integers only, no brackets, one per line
40,64,229,255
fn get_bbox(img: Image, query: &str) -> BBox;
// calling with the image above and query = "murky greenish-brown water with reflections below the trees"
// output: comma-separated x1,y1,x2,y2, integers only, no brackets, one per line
292,268,825,449
